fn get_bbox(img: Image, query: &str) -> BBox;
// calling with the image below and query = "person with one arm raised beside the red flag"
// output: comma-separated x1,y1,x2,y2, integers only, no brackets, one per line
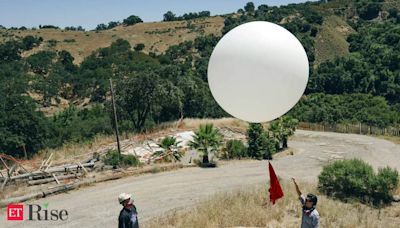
292,178,320,228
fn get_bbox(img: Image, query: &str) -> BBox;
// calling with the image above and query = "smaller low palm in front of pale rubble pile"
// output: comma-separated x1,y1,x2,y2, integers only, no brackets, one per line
153,136,182,162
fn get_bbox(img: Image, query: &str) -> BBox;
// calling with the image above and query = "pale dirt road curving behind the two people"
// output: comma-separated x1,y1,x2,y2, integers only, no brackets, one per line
0,131,400,228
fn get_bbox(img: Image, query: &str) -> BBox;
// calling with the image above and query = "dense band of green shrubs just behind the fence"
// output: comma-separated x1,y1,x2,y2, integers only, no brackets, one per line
290,93,397,128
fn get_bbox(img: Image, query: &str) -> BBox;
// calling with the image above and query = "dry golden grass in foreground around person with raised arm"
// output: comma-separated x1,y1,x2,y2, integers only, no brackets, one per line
144,181,400,228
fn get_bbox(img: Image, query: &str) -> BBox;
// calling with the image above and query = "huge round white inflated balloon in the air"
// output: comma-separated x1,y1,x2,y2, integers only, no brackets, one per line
208,21,309,122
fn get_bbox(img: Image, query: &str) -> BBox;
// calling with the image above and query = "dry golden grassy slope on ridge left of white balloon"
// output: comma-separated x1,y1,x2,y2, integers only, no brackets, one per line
0,16,224,64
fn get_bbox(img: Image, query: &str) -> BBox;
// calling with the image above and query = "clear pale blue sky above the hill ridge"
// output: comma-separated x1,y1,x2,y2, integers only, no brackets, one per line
0,0,316,29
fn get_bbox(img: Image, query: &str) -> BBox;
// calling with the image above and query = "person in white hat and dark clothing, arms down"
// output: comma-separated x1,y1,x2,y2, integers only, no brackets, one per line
118,193,139,228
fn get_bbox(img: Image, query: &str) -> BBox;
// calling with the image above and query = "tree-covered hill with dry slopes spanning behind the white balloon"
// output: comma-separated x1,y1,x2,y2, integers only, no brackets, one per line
0,0,400,155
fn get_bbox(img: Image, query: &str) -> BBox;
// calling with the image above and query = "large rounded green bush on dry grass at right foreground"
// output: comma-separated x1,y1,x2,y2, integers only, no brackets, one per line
318,159,398,205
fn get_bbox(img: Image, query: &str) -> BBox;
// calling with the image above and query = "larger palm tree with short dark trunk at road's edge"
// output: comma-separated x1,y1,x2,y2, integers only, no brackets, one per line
189,124,222,164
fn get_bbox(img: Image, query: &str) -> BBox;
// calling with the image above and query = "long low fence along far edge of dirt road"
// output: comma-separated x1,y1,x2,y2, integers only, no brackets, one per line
298,122,400,137
